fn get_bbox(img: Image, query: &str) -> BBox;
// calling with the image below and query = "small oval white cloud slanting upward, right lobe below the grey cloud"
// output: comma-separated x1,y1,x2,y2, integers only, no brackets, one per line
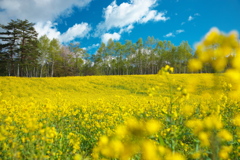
60,23,91,42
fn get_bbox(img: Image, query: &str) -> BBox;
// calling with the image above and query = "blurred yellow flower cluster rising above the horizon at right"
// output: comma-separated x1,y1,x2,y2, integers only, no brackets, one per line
189,28,240,72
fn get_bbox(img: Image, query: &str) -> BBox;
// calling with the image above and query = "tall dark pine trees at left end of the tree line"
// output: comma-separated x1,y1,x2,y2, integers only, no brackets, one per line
0,19,38,76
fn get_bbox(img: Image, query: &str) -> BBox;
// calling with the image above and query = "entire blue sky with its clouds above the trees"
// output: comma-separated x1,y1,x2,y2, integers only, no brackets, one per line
0,0,240,54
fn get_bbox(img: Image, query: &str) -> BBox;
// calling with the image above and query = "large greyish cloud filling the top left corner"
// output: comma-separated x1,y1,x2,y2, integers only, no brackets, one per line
0,0,92,24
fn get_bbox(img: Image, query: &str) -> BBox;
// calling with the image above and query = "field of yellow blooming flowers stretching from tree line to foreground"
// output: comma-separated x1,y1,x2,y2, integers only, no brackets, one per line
0,71,240,160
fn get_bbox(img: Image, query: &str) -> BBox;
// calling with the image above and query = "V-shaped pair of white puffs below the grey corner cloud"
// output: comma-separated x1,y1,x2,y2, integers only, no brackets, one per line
34,21,91,43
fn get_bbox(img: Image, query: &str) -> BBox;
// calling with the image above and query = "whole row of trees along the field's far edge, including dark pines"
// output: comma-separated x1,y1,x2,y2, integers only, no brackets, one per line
0,19,213,77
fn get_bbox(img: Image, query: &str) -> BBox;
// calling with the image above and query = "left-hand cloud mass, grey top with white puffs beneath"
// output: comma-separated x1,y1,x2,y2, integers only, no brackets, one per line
0,0,92,43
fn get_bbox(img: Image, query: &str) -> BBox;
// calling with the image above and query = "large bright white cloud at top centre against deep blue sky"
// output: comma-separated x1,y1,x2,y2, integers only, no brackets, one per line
96,0,169,35
